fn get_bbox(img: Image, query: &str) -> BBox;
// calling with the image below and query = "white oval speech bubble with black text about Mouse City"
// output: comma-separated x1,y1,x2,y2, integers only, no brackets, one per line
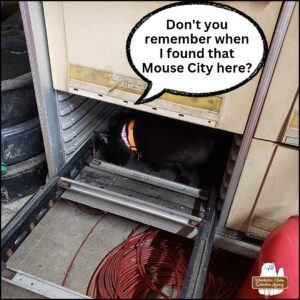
126,2,268,104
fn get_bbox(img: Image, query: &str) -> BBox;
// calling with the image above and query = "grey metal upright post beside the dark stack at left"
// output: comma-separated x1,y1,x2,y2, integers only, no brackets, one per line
20,1,66,178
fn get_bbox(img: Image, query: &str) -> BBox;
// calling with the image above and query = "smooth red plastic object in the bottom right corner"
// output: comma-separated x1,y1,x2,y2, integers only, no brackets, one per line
236,216,299,299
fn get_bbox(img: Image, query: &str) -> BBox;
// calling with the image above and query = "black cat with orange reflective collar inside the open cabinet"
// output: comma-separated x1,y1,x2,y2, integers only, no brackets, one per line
100,112,232,184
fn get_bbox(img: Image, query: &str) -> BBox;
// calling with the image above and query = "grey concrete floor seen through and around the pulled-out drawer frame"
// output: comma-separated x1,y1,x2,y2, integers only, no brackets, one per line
1,197,147,299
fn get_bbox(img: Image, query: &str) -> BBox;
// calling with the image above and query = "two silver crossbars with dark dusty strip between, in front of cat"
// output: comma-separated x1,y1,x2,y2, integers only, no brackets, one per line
58,150,204,239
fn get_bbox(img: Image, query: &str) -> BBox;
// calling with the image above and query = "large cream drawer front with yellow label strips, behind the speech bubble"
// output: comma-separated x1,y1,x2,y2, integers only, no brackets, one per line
43,1,281,133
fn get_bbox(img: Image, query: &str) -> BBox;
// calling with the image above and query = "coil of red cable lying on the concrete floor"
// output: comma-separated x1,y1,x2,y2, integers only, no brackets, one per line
87,229,193,299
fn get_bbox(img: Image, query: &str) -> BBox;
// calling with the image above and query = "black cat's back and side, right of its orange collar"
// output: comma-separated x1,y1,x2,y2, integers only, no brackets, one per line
134,116,223,165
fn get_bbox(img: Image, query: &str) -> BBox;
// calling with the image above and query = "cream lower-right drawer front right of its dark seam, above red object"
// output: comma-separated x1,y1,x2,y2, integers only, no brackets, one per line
248,146,299,238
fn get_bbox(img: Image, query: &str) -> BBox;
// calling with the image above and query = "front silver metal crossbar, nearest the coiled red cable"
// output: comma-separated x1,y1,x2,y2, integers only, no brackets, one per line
59,177,201,238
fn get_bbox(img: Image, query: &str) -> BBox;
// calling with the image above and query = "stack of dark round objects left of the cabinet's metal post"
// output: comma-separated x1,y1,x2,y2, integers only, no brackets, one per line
1,11,47,202
